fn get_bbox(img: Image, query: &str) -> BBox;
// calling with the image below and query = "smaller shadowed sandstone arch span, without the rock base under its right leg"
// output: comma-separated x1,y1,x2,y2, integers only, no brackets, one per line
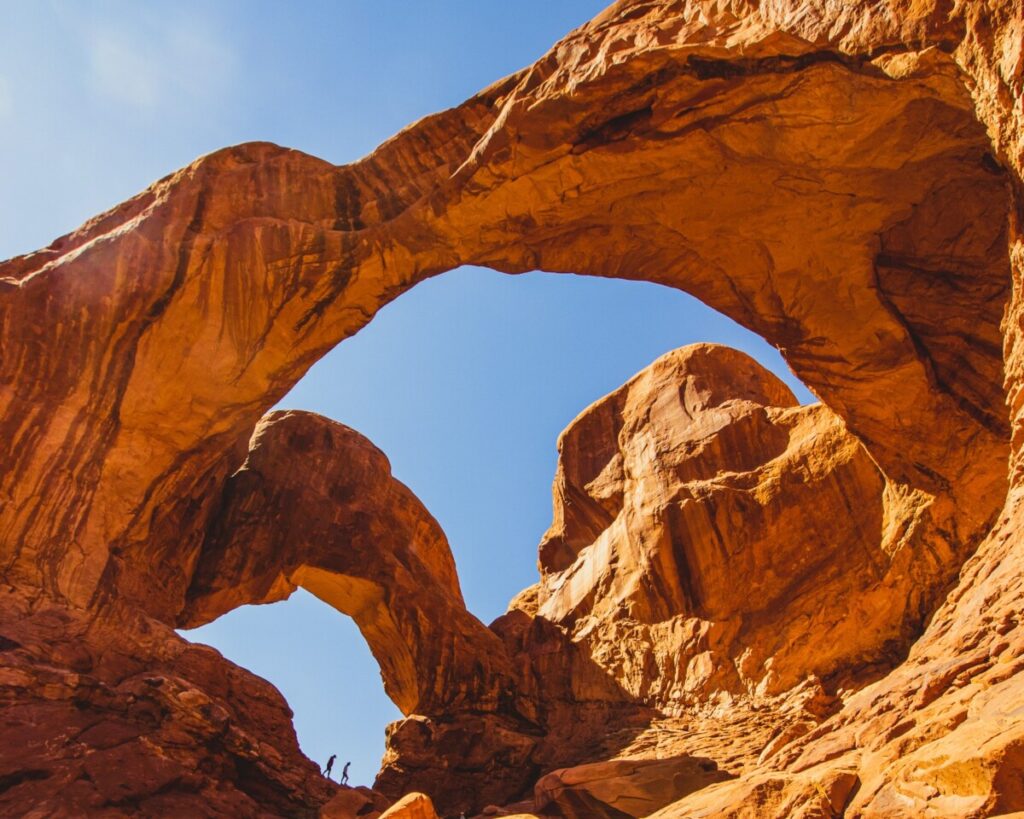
181,412,514,716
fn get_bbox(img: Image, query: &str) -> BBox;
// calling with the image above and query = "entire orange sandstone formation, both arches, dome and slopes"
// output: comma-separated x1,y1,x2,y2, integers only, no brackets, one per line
0,0,1024,816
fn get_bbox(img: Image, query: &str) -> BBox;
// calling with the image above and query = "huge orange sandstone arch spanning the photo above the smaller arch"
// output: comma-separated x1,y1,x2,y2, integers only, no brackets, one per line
4,14,1010,638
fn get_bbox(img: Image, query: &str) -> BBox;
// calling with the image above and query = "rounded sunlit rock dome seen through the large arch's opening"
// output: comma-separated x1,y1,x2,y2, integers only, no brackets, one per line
512,345,944,709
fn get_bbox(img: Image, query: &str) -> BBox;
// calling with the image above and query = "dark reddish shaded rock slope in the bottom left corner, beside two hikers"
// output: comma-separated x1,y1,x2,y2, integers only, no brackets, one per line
0,590,339,819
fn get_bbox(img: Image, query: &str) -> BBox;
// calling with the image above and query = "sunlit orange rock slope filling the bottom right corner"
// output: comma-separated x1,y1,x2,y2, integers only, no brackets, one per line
664,491,1024,817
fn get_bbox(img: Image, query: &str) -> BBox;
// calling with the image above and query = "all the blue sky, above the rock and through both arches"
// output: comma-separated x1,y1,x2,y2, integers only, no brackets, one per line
0,0,810,784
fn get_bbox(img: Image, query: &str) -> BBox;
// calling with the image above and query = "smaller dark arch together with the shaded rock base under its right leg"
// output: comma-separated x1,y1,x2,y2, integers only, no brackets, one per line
180,412,541,810
